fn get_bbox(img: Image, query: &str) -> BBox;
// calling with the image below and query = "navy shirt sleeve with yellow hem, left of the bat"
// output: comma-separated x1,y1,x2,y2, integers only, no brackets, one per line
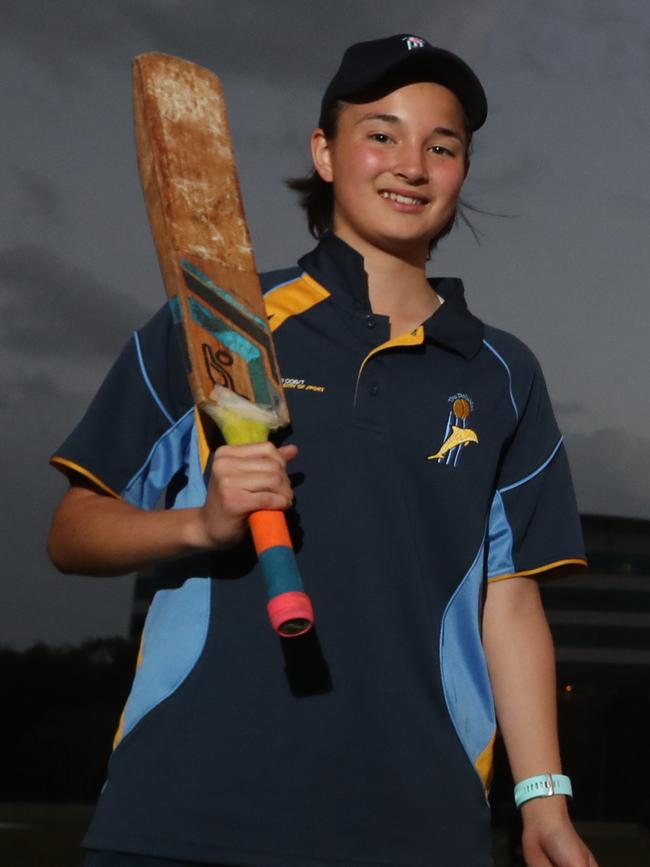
50,305,192,504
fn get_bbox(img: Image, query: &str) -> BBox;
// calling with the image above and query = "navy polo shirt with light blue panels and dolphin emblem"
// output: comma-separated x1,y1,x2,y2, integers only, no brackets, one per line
52,236,584,867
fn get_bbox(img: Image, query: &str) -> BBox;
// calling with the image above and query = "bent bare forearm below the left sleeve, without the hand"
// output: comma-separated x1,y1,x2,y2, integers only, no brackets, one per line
48,488,209,576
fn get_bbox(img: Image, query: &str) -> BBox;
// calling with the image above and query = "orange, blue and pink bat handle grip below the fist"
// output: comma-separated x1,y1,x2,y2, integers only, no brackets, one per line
248,509,314,638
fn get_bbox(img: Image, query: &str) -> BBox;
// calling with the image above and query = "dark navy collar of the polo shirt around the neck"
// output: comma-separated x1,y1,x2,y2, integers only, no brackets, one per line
298,234,484,358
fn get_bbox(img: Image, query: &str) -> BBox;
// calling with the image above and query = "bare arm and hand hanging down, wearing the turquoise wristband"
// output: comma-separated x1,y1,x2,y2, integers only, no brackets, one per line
483,578,598,867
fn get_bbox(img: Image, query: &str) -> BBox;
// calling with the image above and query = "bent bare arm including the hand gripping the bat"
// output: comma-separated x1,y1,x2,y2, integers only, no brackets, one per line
48,443,297,576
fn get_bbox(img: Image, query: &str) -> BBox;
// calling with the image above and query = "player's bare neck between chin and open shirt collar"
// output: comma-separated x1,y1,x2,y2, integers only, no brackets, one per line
337,232,440,337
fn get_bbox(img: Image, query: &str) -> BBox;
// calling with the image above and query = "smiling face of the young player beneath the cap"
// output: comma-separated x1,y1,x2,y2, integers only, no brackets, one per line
312,82,468,261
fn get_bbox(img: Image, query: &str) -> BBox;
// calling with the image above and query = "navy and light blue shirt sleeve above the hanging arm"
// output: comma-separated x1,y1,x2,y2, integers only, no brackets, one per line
487,353,587,581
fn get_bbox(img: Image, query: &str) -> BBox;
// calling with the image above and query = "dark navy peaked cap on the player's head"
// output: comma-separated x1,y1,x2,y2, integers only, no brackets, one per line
320,34,487,132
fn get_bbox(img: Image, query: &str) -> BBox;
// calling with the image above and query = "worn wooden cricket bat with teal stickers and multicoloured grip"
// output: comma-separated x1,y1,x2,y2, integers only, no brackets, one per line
133,53,314,636
